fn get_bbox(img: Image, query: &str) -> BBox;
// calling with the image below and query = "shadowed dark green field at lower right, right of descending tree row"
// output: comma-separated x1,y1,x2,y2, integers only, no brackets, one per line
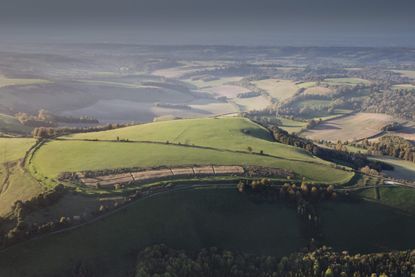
320,199,415,253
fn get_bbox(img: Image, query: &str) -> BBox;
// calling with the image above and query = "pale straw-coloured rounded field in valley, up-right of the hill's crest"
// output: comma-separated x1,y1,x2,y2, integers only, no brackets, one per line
252,79,299,101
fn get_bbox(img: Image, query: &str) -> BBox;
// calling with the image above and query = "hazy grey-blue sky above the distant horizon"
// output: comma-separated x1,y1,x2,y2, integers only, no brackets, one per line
0,0,415,46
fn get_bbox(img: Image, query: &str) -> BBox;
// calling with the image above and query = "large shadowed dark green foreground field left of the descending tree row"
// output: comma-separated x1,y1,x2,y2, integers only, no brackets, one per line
0,189,306,277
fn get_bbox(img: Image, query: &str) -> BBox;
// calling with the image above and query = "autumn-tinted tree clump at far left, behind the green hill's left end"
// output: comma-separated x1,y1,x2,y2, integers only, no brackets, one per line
15,109,99,127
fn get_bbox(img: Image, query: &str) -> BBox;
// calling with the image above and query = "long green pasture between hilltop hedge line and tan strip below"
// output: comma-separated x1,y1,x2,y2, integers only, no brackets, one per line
31,141,353,183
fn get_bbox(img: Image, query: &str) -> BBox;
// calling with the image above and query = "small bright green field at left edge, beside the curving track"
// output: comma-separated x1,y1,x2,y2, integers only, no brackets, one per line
0,138,35,164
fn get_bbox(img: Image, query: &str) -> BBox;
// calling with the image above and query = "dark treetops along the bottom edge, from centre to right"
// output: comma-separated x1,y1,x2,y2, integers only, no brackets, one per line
135,245,415,277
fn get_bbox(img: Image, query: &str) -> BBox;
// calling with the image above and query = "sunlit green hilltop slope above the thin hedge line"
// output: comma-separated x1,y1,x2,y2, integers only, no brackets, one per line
69,117,318,161
